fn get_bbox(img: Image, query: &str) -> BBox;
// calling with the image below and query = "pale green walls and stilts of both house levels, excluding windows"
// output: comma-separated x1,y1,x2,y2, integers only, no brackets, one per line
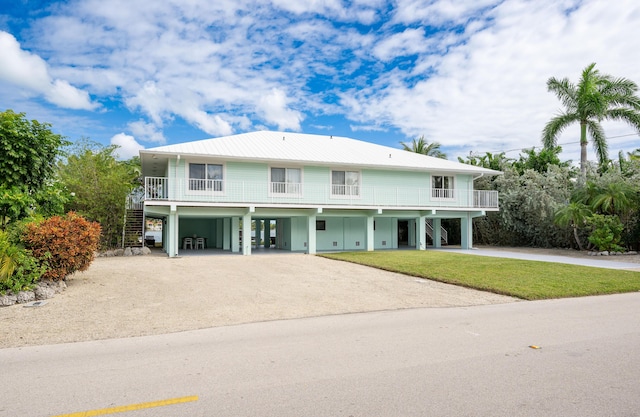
147,156,496,256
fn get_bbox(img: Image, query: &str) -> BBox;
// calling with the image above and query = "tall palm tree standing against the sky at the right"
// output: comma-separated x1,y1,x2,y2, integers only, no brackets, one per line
542,63,640,181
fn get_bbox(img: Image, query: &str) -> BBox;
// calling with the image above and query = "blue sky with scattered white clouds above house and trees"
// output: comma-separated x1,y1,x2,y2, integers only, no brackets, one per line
0,0,640,161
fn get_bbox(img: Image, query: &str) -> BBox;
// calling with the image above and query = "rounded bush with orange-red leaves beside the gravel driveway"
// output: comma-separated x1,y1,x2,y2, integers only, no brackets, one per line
22,212,100,281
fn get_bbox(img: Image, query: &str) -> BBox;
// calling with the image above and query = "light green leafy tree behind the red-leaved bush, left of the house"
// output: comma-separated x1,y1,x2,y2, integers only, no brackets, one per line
59,139,140,248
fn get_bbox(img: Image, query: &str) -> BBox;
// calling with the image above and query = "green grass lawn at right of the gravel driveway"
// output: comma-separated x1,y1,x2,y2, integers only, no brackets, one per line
320,250,640,300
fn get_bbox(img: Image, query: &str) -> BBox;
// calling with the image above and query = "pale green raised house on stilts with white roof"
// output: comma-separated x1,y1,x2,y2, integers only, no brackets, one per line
140,131,499,257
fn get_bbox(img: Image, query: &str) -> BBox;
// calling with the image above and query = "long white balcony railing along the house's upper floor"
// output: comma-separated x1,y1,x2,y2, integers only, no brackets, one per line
144,177,498,209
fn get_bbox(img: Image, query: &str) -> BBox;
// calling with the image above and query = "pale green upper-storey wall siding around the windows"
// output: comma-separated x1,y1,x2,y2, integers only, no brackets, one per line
166,157,473,207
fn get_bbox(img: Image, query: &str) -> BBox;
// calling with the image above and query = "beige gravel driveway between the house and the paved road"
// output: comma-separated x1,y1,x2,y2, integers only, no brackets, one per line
0,254,517,348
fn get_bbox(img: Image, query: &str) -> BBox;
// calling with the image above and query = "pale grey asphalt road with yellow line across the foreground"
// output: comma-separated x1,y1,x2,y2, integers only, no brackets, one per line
0,293,640,417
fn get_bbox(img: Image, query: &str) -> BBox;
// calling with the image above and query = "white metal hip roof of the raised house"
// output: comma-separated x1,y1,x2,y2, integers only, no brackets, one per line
140,131,500,175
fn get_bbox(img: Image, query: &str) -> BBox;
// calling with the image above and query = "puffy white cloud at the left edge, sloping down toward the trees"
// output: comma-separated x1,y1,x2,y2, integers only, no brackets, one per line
0,31,97,110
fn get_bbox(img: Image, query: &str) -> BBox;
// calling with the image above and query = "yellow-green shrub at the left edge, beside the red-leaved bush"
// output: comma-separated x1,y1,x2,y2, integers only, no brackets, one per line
0,231,46,293
